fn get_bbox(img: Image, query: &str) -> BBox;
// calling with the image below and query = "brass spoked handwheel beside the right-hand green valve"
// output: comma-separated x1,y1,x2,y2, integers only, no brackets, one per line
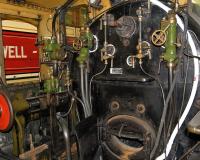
151,30,167,46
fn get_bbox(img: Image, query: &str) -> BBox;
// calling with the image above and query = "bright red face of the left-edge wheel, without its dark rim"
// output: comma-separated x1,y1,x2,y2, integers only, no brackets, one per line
0,94,11,131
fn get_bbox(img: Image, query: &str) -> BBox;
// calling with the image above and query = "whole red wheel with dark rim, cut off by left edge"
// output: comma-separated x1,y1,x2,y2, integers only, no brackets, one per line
0,91,13,132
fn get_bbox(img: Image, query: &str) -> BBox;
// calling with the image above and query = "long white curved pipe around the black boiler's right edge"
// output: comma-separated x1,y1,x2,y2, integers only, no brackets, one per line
151,0,199,160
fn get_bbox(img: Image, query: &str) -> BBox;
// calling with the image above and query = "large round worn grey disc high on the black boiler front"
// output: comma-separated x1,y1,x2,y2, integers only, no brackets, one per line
116,16,136,38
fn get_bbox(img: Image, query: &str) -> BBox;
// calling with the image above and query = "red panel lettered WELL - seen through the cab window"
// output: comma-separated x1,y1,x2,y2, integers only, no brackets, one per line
3,31,40,75
